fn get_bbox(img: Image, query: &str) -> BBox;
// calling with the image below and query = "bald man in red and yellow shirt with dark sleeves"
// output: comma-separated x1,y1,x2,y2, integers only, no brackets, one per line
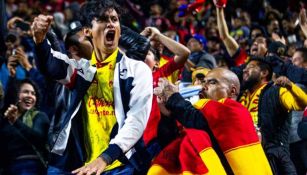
154,68,272,175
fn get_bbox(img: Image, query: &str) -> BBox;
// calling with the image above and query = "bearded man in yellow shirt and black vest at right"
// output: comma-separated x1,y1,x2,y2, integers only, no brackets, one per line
239,57,307,174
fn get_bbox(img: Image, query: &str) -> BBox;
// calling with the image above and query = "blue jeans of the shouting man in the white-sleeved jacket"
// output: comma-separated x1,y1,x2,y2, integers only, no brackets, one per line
47,165,134,175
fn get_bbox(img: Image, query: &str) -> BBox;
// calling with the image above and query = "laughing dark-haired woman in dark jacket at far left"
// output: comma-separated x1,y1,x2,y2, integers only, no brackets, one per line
0,77,49,175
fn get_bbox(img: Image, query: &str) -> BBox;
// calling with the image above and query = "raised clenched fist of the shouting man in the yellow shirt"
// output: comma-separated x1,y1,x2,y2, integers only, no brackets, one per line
31,15,53,44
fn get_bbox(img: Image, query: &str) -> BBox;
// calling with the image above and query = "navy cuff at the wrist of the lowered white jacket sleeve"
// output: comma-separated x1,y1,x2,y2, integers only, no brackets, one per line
99,144,123,165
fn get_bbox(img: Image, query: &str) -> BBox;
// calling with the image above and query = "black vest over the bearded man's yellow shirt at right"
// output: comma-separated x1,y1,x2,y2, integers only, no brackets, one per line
258,82,296,175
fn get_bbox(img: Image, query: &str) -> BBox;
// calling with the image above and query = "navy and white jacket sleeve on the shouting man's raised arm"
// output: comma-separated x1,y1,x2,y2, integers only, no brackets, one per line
35,39,96,87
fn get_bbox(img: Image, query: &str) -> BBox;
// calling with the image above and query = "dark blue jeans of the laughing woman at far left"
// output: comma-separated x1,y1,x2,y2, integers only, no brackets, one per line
4,159,46,175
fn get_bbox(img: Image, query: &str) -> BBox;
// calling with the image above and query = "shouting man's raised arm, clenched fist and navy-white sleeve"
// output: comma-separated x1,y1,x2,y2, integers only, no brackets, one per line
31,15,96,88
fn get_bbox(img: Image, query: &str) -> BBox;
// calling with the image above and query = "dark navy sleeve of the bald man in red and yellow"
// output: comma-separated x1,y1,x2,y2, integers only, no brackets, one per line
166,93,209,129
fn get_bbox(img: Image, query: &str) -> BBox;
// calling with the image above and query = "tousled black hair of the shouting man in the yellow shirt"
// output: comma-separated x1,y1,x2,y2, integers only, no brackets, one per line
80,0,124,27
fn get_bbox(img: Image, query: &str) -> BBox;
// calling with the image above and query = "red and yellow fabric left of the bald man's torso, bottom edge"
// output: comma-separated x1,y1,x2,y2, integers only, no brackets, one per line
148,129,226,175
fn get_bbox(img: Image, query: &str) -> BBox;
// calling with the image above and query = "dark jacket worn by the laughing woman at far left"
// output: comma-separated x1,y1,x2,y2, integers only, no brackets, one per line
0,112,49,168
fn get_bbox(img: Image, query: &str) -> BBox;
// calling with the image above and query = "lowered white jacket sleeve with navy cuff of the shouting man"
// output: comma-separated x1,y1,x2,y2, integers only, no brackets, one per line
102,62,153,164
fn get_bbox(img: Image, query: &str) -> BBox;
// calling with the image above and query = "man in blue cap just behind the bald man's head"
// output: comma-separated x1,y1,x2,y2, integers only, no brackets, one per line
181,34,216,83
